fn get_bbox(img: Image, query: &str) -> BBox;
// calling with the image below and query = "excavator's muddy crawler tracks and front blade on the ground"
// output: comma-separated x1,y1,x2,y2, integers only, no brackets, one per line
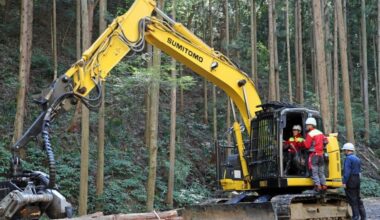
180,192,350,220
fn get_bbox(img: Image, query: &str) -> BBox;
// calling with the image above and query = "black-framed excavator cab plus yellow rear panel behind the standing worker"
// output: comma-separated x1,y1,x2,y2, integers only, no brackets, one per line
245,103,341,192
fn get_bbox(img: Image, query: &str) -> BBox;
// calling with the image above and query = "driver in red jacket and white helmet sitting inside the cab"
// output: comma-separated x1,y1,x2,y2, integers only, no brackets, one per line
283,125,305,174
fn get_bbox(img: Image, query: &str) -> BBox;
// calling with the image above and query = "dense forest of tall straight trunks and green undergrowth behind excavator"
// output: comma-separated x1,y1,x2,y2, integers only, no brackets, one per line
0,0,380,215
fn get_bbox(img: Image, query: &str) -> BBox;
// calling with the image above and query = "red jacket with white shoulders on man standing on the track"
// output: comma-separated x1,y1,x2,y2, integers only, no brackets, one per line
304,128,327,156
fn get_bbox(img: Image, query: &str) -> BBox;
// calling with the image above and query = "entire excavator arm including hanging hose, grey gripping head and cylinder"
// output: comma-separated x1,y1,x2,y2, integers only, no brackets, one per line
5,0,261,217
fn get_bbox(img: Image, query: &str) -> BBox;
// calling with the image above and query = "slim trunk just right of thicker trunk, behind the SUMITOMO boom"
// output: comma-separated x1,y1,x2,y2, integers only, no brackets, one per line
166,0,177,208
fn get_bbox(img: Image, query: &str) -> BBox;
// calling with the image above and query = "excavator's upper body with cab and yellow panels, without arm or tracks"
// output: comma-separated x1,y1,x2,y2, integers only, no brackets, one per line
217,103,342,193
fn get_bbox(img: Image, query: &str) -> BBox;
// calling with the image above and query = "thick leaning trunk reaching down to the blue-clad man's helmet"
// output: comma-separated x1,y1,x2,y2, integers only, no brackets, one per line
335,0,355,143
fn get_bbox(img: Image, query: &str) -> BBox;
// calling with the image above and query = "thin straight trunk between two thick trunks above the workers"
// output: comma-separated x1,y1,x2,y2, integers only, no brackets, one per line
333,7,339,132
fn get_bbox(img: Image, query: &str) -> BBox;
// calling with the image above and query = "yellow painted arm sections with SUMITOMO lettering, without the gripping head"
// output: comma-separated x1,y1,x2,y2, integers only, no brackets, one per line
61,0,261,132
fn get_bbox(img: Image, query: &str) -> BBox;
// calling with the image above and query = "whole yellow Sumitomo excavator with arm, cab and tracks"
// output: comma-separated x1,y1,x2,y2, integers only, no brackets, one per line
0,0,350,219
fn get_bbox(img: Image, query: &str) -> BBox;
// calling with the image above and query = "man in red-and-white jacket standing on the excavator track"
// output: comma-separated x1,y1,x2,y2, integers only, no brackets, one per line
304,118,327,192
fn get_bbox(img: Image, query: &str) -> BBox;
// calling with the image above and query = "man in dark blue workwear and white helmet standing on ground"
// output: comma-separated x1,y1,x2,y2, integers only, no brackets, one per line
342,143,366,219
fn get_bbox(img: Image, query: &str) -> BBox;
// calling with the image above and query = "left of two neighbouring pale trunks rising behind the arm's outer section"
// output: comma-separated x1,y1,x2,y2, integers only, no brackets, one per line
78,0,91,215
